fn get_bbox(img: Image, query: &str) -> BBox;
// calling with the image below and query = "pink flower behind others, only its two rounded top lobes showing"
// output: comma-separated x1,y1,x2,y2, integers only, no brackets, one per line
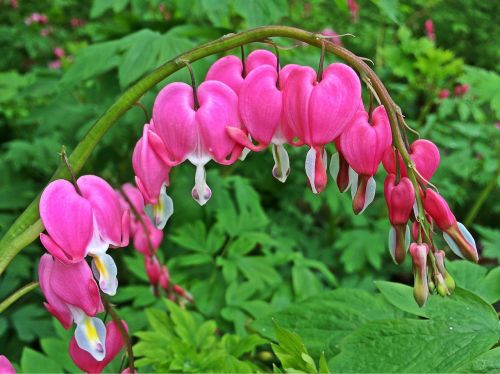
206,49,277,94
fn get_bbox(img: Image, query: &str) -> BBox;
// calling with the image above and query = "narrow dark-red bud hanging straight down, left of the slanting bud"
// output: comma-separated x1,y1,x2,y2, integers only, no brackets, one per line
384,174,415,264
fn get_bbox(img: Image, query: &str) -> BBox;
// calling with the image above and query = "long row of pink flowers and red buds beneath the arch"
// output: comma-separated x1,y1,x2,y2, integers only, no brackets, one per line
133,50,478,304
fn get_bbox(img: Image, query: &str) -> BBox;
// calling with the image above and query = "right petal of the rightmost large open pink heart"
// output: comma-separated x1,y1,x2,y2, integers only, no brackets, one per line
309,64,361,145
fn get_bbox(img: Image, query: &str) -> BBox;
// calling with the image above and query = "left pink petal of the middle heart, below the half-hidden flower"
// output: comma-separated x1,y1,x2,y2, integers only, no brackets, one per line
239,65,282,145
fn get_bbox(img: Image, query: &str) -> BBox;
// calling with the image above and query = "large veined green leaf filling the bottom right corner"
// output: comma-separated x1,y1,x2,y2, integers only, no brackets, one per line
329,287,500,372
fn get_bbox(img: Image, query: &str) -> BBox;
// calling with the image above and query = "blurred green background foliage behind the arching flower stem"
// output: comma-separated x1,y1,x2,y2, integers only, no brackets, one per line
0,0,500,372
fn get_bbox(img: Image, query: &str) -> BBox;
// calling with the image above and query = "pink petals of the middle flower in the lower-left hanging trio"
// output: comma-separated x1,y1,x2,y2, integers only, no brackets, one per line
49,260,104,317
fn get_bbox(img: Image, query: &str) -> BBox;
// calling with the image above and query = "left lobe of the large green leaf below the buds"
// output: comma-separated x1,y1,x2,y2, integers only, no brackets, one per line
252,289,401,358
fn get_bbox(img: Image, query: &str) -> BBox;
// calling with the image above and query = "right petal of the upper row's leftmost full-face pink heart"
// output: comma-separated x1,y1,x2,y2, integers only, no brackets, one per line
196,81,242,163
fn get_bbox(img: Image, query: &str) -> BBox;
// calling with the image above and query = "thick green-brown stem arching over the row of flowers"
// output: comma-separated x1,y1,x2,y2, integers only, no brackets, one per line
0,26,425,274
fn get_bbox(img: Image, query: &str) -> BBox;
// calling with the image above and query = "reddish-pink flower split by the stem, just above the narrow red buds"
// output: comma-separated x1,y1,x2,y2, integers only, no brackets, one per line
382,139,440,181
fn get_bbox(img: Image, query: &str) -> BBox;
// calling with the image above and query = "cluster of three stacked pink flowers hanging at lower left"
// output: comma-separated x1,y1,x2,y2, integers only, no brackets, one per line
38,175,130,372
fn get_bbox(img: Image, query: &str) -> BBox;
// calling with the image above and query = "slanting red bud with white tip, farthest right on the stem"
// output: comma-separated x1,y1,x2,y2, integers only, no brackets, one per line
423,188,479,262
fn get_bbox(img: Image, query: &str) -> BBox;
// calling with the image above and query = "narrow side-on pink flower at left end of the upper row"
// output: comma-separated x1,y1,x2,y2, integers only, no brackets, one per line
132,121,174,229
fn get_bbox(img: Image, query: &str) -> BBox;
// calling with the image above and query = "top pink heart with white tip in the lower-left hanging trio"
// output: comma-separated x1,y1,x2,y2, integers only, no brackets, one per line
40,175,130,295
